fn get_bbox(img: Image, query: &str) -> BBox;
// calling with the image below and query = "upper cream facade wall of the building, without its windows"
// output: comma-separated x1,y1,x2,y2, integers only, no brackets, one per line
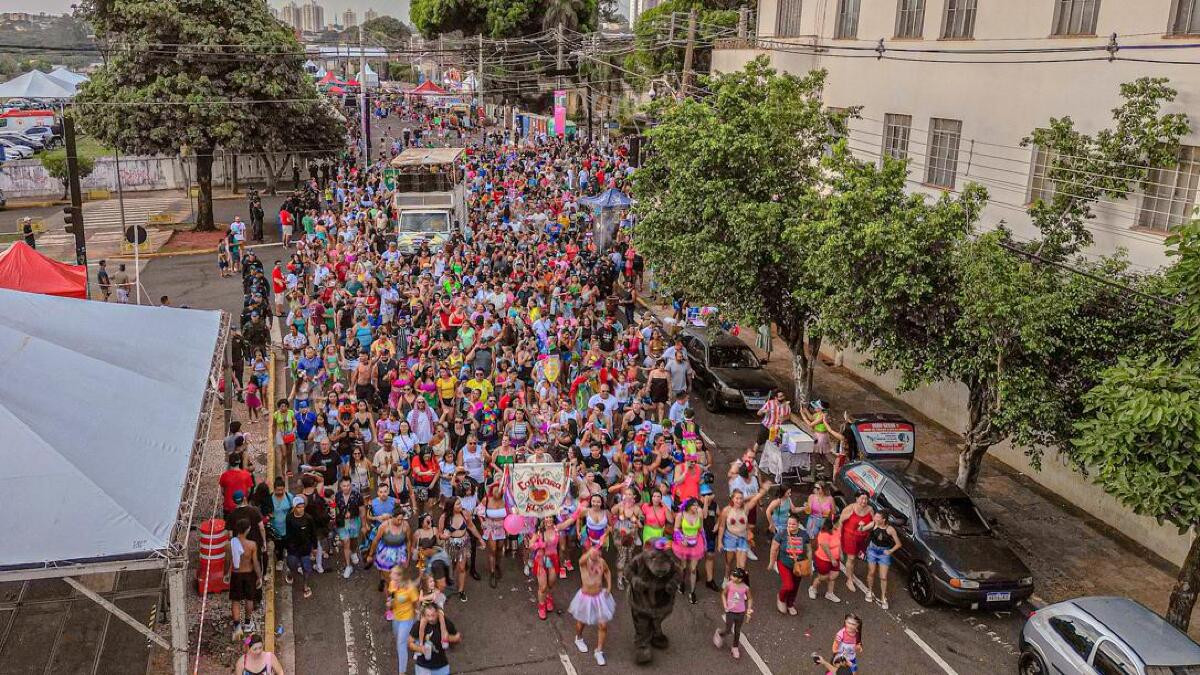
713,0,1200,269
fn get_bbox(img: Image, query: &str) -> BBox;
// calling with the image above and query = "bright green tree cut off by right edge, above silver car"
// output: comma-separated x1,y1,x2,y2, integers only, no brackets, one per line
1073,221,1200,632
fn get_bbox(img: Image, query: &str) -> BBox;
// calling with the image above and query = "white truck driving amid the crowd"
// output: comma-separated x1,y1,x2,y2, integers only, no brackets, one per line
385,148,467,252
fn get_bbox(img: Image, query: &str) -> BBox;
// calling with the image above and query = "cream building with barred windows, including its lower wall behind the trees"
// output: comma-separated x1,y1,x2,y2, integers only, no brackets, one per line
713,0,1200,563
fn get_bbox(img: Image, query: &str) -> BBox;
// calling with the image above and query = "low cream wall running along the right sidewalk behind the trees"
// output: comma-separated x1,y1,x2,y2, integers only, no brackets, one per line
824,350,1193,565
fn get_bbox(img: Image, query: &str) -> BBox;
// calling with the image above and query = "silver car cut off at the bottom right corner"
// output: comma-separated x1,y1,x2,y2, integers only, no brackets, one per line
1018,596,1200,675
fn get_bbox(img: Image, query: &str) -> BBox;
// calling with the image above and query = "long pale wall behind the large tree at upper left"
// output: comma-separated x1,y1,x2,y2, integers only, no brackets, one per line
0,150,298,199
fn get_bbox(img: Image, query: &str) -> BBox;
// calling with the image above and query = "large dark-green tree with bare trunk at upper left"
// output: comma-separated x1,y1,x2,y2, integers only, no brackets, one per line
74,0,341,229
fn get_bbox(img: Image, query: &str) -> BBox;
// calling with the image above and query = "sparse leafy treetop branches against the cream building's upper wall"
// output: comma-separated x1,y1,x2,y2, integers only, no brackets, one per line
1021,77,1190,259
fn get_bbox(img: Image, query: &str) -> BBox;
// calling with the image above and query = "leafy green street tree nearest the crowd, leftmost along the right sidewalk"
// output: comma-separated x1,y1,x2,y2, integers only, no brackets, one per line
634,58,850,400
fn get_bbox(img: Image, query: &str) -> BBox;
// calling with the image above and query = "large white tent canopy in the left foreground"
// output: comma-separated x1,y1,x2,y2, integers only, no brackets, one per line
0,291,221,569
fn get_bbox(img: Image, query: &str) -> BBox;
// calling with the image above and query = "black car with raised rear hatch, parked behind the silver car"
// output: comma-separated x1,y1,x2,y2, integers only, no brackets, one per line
836,459,1033,609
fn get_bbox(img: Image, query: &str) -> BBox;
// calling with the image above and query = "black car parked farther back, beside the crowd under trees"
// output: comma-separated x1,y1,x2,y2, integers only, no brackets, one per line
679,327,776,412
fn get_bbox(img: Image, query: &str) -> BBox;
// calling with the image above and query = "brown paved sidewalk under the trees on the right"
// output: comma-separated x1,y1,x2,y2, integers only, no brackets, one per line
650,293,1200,639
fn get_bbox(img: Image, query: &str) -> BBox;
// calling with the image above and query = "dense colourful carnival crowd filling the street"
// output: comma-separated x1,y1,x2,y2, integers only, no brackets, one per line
220,96,873,674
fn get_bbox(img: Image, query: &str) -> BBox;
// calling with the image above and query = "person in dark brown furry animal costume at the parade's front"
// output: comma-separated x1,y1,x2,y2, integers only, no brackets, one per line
626,538,680,664
